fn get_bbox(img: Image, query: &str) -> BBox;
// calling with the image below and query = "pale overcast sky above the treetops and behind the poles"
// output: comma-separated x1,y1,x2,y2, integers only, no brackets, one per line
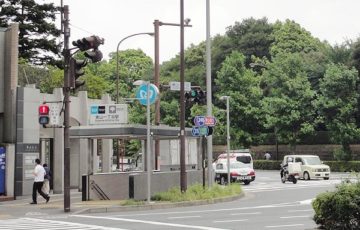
57,0,360,62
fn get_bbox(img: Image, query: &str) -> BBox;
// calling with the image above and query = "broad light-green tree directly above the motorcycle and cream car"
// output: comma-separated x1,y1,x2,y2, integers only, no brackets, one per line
261,53,315,148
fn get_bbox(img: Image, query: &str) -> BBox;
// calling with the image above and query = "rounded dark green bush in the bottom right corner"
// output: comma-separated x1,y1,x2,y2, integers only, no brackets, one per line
312,181,360,230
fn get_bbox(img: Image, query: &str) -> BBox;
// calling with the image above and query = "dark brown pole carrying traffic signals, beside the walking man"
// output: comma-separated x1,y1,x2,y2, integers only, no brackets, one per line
62,5,70,212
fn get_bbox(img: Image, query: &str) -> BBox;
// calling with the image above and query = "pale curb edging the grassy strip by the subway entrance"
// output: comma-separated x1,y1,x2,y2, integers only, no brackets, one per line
76,192,245,214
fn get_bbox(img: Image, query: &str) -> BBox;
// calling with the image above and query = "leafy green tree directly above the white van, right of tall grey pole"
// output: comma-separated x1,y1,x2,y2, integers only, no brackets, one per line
215,51,261,147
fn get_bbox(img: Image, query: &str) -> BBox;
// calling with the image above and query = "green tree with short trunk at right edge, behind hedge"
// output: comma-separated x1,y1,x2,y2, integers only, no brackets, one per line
317,64,360,160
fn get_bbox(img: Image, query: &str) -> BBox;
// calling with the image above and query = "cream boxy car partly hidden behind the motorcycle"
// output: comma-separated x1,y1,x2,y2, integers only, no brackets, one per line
283,155,330,180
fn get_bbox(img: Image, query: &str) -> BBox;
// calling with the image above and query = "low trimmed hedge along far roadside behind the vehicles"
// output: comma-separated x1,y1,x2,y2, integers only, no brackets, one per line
254,160,360,172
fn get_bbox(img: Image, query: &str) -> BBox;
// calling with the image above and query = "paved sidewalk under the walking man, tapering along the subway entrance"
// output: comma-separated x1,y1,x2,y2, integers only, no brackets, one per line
0,190,244,220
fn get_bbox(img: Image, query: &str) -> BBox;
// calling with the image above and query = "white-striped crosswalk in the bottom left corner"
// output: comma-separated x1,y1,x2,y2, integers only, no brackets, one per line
0,218,125,230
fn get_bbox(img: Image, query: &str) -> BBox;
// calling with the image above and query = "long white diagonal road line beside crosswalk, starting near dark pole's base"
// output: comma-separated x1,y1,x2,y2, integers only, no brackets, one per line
72,215,227,230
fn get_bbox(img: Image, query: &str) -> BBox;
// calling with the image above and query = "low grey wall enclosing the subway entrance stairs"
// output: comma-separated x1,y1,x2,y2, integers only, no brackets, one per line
88,170,202,200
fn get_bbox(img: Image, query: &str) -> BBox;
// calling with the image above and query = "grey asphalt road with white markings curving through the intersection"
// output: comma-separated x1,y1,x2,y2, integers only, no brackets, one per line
0,171,348,230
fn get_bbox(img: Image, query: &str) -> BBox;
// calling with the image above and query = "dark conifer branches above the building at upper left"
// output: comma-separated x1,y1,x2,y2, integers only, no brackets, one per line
0,0,61,65
